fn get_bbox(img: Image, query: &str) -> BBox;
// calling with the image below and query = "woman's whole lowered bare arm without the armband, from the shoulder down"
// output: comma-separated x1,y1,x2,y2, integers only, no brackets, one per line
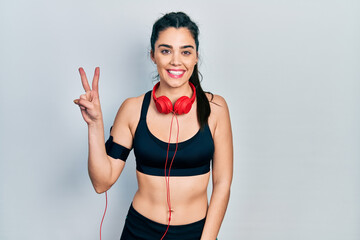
201,95,233,240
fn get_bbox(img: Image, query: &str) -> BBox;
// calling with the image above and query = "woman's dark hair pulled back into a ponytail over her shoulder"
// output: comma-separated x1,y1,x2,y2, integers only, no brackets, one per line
150,12,210,128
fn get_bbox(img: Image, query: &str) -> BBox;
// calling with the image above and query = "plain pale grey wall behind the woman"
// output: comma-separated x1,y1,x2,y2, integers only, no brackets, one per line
0,0,360,240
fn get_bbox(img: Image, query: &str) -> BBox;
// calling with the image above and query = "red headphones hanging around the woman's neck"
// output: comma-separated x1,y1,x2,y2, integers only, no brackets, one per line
153,82,196,115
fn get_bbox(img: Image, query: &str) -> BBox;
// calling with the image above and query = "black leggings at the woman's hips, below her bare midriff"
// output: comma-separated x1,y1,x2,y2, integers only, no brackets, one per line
120,205,205,240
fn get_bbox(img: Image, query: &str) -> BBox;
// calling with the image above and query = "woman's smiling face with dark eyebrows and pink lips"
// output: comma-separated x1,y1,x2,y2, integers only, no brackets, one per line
151,27,198,87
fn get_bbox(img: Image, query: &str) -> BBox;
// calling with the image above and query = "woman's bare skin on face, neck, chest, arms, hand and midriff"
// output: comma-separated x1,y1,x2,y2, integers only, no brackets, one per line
74,28,233,240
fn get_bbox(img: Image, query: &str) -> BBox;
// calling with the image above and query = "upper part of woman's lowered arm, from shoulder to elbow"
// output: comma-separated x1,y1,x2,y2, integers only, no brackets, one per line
210,95,233,187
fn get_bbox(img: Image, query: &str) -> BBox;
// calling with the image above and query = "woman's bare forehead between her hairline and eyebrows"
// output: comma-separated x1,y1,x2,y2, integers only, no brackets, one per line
155,27,195,48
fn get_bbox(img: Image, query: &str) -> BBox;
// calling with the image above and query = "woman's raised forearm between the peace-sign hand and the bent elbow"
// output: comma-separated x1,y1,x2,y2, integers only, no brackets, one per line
88,121,111,193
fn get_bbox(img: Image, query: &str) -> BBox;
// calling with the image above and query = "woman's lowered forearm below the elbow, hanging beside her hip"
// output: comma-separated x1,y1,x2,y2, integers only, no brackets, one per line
201,183,230,240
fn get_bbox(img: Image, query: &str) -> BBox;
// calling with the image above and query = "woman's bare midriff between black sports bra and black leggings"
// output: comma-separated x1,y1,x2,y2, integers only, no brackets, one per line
132,171,210,225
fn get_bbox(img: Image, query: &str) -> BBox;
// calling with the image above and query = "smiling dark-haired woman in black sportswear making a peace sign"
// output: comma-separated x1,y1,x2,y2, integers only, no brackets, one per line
74,12,233,240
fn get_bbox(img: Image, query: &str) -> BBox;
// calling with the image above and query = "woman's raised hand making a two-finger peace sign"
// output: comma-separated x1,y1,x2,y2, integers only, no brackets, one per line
74,67,102,125
